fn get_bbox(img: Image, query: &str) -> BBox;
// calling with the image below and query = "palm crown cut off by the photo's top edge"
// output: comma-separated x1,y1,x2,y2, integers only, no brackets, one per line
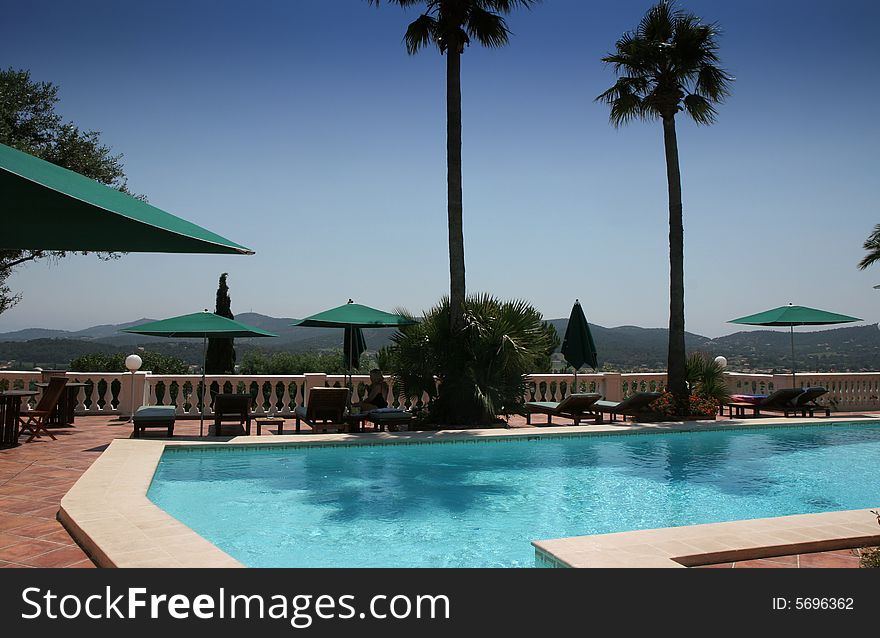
369,0,540,54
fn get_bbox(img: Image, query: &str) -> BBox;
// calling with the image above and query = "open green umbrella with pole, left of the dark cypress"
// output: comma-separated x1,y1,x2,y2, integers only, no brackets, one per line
122,310,278,436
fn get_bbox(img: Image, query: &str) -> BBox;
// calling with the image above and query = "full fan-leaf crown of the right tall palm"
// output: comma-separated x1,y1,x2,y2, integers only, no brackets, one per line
596,1,733,126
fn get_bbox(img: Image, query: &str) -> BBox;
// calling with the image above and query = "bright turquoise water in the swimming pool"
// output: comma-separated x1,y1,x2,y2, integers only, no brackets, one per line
148,425,880,567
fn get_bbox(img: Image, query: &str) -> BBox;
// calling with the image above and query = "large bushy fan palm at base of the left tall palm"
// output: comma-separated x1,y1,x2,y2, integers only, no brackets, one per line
390,294,559,425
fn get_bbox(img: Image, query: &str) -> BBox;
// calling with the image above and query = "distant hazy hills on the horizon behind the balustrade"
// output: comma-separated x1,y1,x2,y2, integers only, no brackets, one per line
0,312,880,372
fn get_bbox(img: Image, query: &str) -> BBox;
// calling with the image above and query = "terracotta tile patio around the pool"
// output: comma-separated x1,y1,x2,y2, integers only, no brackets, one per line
0,413,880,568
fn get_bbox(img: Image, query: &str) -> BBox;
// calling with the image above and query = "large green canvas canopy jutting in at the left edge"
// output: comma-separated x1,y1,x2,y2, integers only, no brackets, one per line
0,144,253,255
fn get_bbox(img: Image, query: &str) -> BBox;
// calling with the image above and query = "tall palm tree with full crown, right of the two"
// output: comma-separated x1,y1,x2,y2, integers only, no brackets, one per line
596,1,733,407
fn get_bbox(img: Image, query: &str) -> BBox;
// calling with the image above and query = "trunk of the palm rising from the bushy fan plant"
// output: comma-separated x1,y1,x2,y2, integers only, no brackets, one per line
446,43,465,332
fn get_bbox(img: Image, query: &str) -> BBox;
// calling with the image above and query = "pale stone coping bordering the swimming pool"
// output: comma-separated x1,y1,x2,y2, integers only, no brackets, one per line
58,418,880,568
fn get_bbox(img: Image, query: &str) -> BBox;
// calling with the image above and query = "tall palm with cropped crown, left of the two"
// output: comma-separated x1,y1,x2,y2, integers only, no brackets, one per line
368,0,540,329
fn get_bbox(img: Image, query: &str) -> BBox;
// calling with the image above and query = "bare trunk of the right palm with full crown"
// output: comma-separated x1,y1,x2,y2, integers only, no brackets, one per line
663,116,688,409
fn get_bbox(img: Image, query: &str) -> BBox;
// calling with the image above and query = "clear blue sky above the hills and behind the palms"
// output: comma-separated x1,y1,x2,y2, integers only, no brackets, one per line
0,0,880,336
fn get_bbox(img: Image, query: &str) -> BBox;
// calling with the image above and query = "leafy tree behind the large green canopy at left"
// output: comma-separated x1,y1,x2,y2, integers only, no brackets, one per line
0,68,138,313
